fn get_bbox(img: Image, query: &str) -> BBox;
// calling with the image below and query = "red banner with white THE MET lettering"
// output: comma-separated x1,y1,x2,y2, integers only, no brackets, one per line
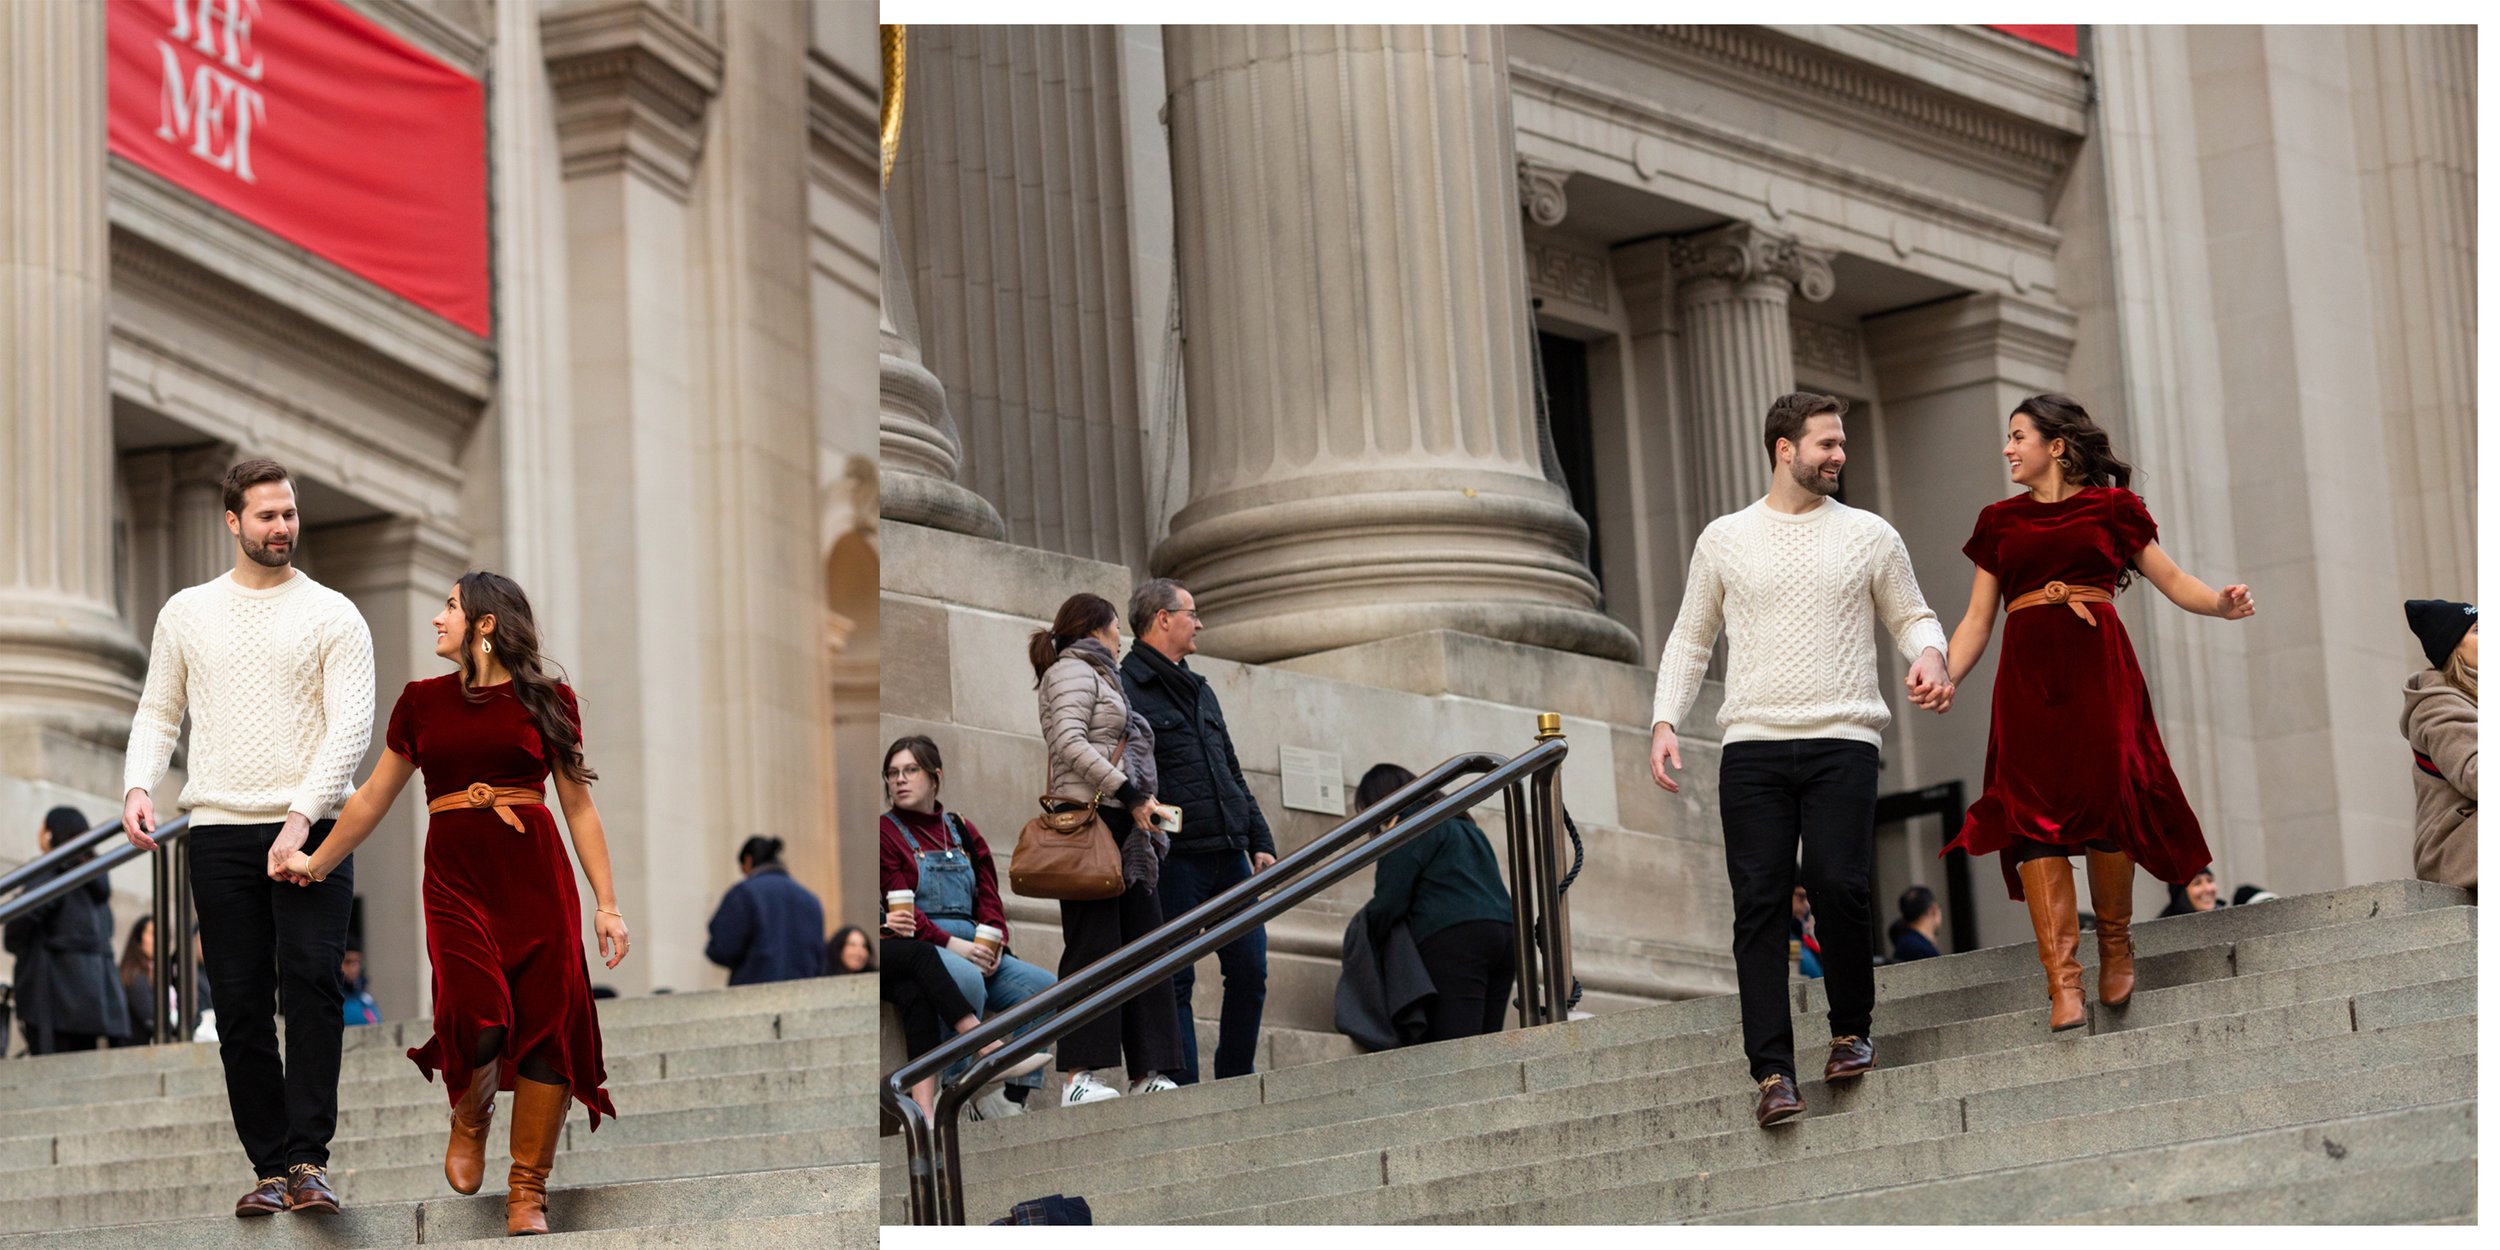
108,0,490,335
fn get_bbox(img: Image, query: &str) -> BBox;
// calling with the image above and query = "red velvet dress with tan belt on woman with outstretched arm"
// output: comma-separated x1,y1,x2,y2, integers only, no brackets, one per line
1945,488,2213,900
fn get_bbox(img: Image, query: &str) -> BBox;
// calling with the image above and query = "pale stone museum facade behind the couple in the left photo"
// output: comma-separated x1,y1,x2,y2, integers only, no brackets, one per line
0,0,878,1018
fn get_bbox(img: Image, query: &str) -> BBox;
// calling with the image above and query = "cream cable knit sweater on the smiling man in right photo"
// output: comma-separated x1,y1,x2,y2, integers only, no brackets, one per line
1650,500,1945,745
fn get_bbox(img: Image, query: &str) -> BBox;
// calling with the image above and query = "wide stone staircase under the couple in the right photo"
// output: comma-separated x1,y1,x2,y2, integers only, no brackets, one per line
883,883,2478,1225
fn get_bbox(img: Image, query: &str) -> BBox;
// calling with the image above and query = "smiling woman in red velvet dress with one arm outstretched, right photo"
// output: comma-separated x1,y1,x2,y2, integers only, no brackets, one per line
1945,395,2258,1030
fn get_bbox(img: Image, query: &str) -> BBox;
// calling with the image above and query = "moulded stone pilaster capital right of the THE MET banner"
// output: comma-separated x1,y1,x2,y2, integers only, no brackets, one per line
538,0,723,200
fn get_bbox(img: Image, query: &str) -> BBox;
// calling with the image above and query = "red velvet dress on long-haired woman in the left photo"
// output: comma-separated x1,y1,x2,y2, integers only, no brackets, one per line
397,673,618,1133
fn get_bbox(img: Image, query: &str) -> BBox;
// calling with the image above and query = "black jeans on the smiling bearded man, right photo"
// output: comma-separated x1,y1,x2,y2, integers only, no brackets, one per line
1720,738,1880,1080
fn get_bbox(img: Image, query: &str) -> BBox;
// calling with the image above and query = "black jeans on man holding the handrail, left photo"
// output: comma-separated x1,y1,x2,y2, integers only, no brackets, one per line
190,820,355,1178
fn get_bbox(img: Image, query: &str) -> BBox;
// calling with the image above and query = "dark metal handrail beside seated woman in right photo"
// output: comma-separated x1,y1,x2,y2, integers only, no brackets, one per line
878,713,1573,1225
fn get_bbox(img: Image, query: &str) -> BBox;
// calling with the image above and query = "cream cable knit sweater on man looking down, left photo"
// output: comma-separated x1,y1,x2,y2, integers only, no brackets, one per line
123,570,373,825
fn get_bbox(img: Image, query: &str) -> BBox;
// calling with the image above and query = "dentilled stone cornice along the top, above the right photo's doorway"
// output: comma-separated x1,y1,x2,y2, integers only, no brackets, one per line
1615,25,2078,178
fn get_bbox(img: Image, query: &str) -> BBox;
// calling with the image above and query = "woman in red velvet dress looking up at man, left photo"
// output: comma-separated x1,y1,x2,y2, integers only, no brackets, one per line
283,573,628,1238
